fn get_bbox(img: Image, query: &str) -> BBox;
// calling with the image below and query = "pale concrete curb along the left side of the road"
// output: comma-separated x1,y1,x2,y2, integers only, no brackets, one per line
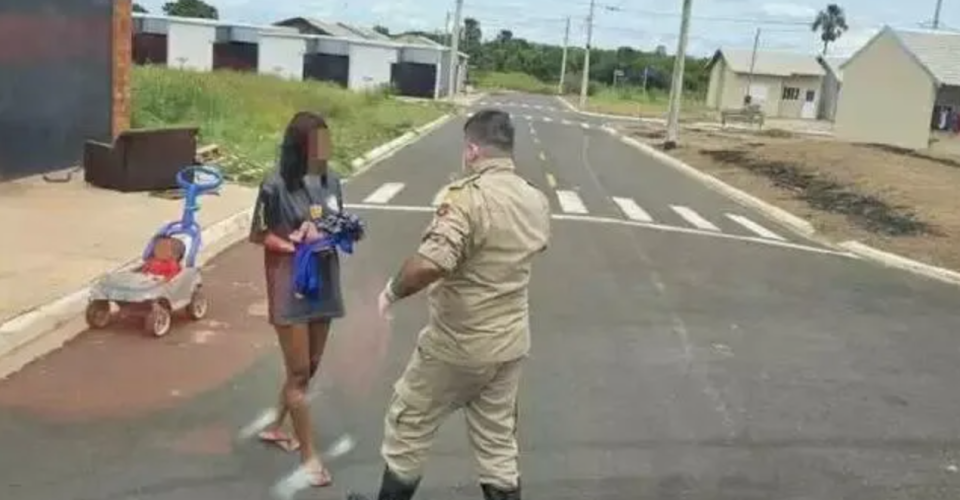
0,113,454,380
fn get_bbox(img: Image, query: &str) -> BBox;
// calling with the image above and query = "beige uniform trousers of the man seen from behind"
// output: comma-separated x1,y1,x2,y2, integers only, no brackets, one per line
381,347,522,490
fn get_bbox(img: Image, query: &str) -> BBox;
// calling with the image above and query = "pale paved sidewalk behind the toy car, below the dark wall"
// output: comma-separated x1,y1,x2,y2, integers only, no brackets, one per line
0,168,254,324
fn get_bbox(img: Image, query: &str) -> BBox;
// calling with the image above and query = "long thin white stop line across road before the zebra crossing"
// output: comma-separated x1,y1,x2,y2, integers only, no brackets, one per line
344,203,861,260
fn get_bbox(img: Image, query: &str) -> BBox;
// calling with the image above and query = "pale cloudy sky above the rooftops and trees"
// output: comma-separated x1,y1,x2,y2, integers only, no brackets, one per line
138,0,960,57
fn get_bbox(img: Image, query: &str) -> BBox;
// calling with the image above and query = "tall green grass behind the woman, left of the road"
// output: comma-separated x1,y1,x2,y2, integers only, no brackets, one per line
132,66,450,182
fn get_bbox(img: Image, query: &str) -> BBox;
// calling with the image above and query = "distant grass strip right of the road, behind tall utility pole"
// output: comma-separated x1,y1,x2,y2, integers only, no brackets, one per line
567,87,710,120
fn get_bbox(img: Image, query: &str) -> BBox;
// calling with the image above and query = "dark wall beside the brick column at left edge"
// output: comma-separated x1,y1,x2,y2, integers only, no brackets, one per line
0,0,113,181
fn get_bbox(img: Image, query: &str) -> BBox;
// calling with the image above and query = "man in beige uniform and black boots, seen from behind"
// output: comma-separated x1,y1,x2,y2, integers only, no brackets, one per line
352,110,550,500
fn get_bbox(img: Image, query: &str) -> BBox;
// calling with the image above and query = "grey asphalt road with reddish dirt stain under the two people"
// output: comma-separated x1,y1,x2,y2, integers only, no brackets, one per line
0,96,960,500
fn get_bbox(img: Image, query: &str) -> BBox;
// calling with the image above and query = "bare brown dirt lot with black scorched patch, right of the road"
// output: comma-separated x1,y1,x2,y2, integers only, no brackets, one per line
621,124,960,269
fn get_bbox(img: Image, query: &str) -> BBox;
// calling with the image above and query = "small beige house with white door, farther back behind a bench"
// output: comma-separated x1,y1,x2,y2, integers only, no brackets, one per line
707,49,825,119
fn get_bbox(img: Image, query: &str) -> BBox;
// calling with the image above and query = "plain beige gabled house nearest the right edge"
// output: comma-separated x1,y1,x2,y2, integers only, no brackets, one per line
834,27,960,149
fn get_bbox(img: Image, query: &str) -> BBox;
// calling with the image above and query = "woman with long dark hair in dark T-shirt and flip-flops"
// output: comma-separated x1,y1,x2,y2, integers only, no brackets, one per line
250,112,344,487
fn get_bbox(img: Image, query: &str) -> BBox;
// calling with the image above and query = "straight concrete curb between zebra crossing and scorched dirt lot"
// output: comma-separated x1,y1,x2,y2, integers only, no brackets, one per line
602,127,816,238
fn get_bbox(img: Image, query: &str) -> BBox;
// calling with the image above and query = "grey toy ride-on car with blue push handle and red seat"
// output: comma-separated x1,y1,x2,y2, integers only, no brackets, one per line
86,166,223,337
